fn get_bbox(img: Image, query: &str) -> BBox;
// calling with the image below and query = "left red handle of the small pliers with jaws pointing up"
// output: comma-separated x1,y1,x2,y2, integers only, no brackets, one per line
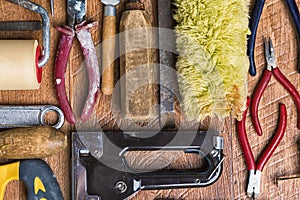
250,69,272,136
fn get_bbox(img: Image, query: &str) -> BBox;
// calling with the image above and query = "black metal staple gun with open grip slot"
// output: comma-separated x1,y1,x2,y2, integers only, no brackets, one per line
72,132,223,200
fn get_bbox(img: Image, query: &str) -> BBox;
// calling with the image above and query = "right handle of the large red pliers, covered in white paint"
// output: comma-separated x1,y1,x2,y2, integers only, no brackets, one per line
76,21,100,121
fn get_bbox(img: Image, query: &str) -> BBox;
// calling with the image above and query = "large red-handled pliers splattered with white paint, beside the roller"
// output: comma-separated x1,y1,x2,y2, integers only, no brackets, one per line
54,0,100,124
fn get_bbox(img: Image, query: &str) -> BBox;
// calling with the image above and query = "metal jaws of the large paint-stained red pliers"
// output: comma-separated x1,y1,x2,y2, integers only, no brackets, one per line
67,0,86,28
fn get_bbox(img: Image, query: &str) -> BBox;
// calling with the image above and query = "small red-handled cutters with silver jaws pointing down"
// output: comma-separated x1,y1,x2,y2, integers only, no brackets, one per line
237,97,287,198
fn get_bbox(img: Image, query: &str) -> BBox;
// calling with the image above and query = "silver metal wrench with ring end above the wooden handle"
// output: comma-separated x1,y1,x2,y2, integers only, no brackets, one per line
0,105,64,129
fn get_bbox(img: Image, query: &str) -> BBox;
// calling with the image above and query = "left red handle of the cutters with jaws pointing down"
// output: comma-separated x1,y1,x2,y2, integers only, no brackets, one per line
236,97,255,170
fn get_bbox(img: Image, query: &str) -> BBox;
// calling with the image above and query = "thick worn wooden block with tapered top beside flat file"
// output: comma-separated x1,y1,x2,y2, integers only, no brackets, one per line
119,1,159,123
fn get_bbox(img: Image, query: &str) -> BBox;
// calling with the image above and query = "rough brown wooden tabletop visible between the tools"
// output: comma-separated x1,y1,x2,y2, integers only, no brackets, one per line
0,0,300,200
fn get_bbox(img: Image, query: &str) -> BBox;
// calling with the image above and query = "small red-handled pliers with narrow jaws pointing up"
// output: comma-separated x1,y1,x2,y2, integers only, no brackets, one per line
250,38,300,135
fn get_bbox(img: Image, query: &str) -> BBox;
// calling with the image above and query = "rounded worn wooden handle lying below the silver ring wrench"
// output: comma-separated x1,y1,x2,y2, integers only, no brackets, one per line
0,126,67,159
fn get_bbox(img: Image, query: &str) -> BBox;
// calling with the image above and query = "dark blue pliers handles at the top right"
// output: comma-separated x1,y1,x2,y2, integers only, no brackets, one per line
248,0,300,76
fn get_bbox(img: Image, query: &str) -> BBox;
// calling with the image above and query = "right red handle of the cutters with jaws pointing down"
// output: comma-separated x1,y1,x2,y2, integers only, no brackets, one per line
256,104,287,171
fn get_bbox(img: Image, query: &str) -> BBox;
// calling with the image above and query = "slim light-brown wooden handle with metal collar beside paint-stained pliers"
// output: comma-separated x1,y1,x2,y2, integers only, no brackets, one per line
101,0,120,95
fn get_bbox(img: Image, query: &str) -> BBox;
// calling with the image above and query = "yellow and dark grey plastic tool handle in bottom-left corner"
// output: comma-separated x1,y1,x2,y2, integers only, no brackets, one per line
0,159,63,200
